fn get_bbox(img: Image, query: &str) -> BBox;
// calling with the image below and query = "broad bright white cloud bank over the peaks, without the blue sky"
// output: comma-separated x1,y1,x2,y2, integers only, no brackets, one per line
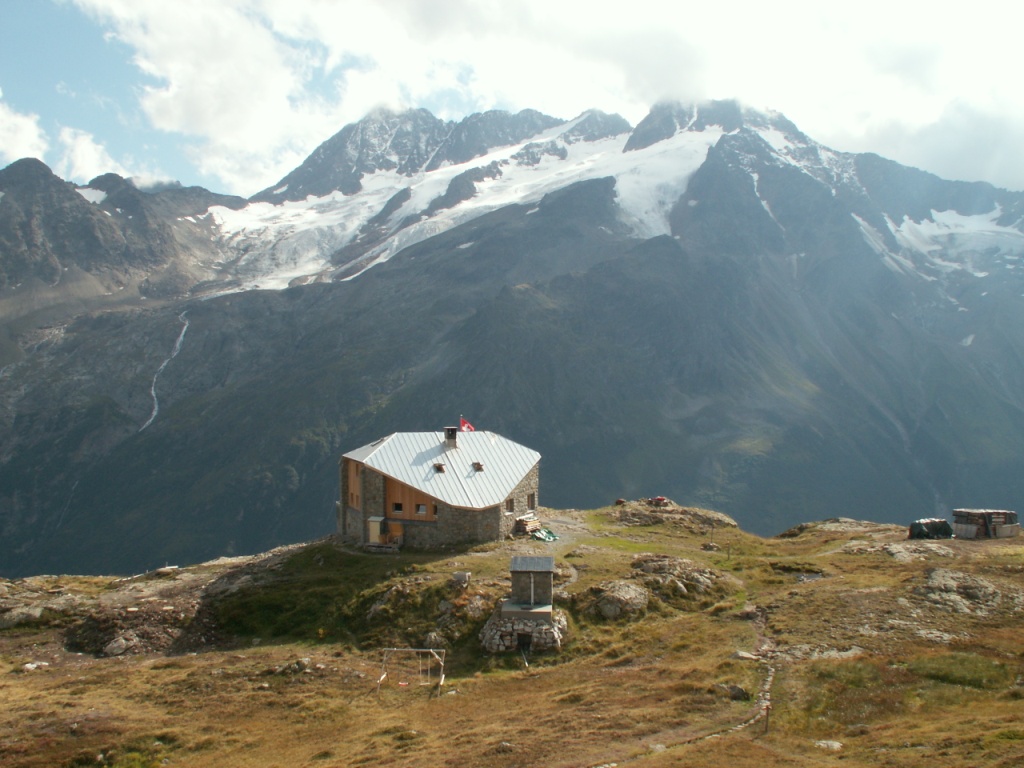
66,0,1024,194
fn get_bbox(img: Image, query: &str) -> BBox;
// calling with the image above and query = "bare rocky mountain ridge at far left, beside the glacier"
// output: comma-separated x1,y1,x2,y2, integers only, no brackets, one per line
0,159,245,358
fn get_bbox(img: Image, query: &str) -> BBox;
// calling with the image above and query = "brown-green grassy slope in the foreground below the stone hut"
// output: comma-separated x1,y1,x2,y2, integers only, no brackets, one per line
0,510,1024,768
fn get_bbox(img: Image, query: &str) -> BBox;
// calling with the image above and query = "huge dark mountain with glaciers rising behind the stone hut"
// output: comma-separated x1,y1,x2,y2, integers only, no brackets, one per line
0,102,1024,574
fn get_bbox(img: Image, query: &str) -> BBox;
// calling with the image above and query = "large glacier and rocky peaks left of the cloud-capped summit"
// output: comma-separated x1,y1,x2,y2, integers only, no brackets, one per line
212,110,671,287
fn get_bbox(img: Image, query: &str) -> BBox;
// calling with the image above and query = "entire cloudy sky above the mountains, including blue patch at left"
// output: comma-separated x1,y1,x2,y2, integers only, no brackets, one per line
0,0,1024,196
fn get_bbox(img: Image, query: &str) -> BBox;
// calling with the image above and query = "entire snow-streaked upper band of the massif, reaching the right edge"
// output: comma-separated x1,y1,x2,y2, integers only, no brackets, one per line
19,101,1024,307
